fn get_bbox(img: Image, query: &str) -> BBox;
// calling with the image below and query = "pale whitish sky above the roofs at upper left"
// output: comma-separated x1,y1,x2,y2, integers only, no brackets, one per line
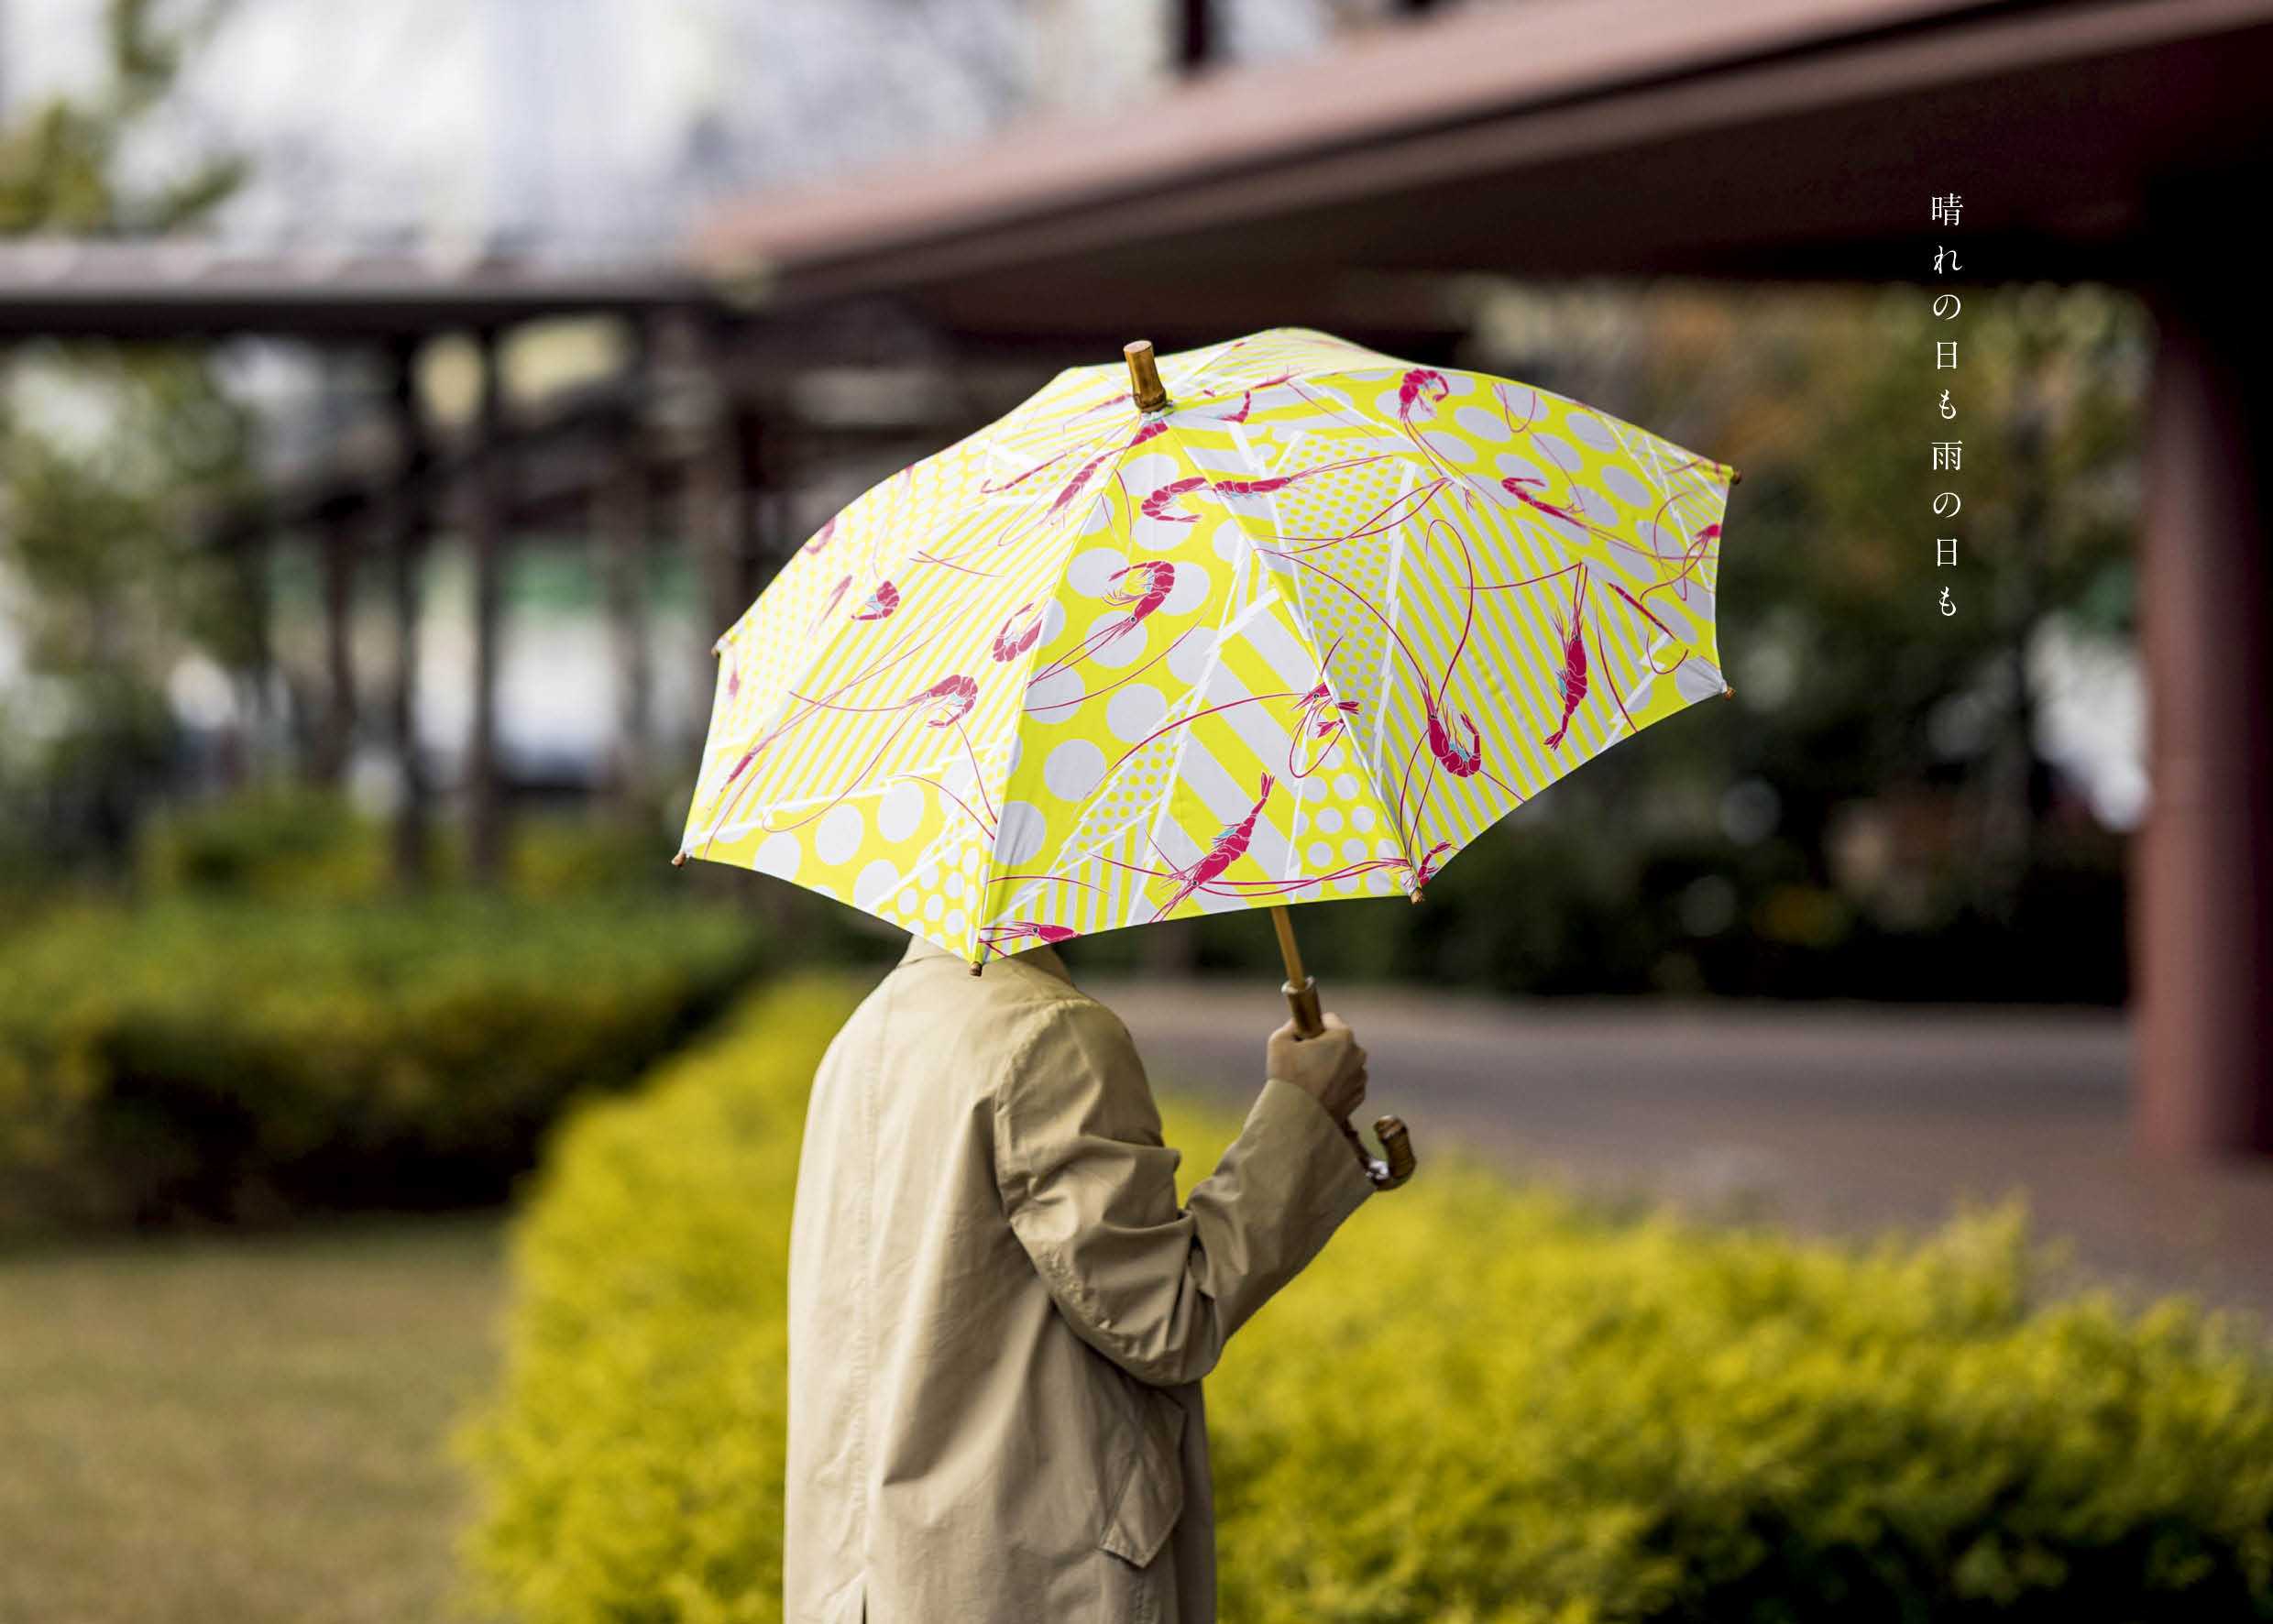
0,0,1345,255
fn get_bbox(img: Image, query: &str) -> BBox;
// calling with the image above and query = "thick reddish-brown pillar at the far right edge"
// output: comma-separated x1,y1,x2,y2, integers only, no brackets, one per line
2132,212,2273,1163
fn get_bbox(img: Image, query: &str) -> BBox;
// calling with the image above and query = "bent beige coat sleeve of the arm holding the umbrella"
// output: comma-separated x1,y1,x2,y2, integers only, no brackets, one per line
995,1002,1373,1388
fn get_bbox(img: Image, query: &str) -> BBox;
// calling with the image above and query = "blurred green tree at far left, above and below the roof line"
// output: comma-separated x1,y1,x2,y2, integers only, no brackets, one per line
0,0,264,883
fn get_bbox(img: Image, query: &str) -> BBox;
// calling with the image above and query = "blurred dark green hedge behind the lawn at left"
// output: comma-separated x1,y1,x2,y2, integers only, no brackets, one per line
0,897,757,1231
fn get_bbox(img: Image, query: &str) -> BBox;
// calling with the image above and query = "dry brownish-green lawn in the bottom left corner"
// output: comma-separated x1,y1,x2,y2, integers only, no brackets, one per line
0,1217,505,1624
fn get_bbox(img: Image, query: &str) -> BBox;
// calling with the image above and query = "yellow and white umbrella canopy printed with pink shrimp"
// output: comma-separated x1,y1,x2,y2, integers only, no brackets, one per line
682,329,1734,963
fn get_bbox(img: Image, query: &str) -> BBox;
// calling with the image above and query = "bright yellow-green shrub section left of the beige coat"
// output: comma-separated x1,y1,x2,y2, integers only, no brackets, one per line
466,982,852,1624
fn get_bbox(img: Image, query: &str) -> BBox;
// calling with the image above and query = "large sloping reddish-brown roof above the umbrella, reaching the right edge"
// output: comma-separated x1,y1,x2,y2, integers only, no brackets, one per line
693,0,2273,332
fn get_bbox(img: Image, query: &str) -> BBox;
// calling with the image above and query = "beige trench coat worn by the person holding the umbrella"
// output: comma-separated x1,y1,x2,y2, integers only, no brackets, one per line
785,943,1373,1624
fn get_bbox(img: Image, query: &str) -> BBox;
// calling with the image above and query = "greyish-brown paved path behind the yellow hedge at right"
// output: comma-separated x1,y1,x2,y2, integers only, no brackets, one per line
1084,982,2273,1309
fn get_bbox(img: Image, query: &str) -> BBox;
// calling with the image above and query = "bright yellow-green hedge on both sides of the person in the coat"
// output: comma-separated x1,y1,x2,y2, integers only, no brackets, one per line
464,986,2273,1624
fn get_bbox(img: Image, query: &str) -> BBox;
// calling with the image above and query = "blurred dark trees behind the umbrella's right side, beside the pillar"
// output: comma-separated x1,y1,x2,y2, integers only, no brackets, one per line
1075,281,2148,1002
